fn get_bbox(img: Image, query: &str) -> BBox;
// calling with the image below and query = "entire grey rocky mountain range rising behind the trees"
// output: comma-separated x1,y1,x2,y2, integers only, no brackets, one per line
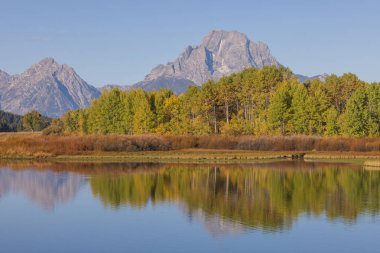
0,30,324,117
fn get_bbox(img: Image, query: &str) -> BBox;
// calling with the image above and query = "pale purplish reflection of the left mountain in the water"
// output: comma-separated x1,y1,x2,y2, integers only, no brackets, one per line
0,168,86,209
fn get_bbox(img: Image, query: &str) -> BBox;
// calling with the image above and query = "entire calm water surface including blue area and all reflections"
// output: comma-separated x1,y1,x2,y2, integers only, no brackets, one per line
0,161,380,253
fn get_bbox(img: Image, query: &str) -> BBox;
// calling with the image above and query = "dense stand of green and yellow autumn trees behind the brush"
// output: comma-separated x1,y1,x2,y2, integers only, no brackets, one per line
46,67,380,136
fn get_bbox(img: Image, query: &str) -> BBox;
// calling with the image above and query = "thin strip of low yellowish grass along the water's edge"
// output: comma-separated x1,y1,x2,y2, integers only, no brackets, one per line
0,149,380,163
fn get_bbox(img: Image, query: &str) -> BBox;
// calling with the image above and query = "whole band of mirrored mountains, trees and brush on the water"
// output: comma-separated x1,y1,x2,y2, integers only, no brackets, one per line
0,161,380,231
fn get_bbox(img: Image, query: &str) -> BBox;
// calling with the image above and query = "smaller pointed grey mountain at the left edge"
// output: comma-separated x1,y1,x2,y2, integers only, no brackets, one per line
0,58,100,117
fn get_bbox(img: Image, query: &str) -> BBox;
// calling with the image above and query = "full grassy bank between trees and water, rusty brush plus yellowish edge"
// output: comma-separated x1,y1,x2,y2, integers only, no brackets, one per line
0,133,380,162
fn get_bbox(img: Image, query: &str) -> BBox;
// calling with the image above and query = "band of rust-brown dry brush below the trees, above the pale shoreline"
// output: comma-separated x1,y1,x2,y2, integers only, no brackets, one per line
0,133,380,158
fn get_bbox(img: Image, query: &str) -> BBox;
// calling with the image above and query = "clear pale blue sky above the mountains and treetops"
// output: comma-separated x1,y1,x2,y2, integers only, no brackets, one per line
0,0,380,86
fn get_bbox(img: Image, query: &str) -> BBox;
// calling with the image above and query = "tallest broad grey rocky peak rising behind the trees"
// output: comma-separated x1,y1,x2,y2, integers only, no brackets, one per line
135,30,280,93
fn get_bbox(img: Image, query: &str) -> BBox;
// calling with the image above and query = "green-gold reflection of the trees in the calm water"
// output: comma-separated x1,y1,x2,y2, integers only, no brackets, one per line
90,165,380,230
